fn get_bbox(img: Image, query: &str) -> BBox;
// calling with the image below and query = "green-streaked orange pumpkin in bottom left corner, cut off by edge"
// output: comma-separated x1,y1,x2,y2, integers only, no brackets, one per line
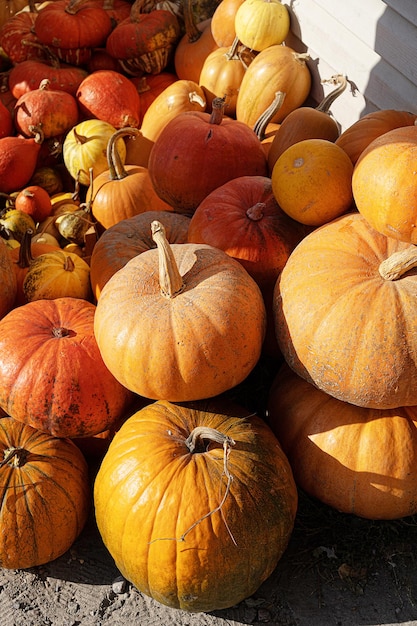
0,417,91,569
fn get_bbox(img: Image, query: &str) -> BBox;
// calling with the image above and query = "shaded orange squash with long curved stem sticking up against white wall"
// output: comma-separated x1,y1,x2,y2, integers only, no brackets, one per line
268,74,347,173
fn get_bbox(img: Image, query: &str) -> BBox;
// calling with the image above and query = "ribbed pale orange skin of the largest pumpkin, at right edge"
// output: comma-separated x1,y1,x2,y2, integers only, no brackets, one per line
274,213,417,409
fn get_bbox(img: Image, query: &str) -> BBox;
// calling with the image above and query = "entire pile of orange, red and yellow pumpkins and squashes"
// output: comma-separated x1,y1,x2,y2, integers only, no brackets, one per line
0,0,417,611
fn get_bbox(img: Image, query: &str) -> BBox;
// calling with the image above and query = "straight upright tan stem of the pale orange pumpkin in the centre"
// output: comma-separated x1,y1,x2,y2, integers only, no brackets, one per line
151,220,185,298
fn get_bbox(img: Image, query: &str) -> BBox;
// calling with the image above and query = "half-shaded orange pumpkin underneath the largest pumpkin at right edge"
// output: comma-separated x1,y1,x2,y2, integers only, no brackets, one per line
267,365,417,520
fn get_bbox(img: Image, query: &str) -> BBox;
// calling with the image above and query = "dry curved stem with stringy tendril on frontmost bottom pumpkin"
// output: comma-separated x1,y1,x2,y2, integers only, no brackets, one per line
149,426,237,545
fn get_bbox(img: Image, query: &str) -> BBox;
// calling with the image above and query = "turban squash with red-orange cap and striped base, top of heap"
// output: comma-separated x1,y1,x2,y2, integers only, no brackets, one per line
106,9,181,74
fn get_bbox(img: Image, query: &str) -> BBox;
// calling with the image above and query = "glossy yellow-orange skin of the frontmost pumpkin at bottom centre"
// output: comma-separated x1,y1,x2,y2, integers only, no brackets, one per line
94,401,297,612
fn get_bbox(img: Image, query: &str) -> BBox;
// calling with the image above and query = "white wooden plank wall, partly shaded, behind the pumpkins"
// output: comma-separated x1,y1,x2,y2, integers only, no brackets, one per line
282,0,417,130
